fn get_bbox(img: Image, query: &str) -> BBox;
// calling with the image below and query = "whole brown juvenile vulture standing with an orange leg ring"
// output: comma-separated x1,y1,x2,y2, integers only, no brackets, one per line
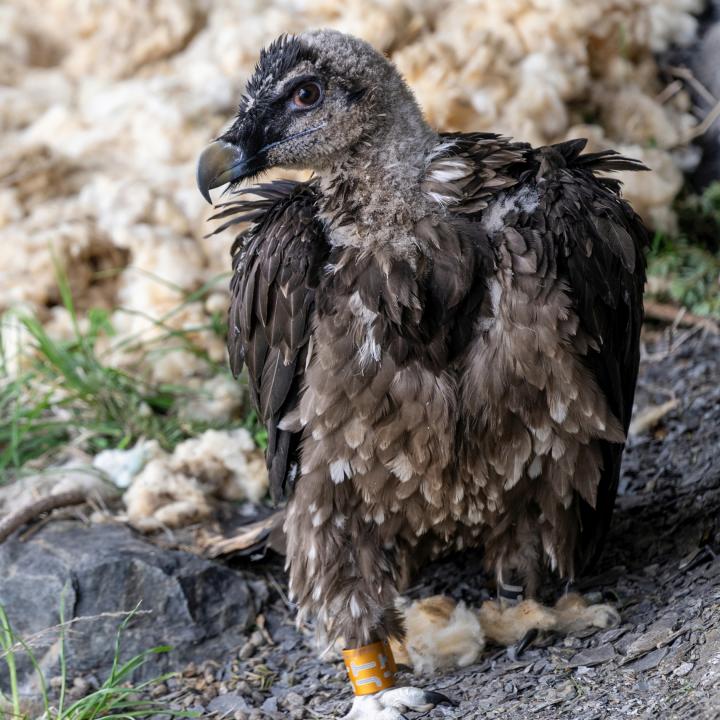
198,30,646,718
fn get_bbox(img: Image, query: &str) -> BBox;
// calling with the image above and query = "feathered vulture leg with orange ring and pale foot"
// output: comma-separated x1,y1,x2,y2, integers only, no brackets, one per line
285,478,458,720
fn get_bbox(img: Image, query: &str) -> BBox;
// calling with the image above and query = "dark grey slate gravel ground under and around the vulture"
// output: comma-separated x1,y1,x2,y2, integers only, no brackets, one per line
148,329,720,720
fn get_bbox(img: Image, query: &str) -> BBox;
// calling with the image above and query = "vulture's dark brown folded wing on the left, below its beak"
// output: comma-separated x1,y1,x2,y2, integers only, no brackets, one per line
215,180,327,500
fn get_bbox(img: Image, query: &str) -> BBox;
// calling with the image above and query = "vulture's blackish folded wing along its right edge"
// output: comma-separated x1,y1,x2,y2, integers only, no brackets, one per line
524,141,648,569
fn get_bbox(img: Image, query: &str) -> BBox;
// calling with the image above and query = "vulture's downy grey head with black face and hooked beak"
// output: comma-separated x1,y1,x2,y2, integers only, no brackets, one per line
197,30,432,202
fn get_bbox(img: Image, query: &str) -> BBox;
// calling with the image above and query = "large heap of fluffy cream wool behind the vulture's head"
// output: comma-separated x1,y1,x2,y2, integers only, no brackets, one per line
0,0,702,394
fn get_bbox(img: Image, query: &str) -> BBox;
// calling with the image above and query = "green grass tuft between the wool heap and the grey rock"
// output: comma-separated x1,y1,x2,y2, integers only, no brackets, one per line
0,265,262,482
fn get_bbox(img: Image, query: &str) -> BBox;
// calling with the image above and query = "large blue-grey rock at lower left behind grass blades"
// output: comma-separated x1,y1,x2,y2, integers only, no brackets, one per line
0,522,265,691
